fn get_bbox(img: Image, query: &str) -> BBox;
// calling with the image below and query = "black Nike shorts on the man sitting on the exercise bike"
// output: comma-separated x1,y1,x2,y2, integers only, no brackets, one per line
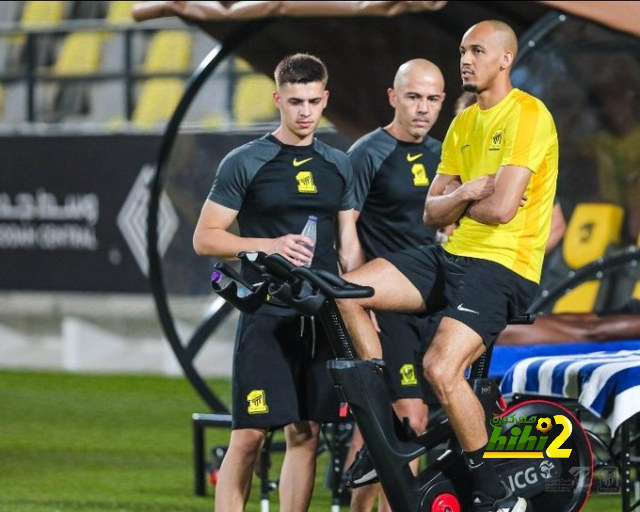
384,245,538,346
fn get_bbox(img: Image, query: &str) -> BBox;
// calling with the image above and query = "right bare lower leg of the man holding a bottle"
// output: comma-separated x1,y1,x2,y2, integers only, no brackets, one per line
280,421,320,512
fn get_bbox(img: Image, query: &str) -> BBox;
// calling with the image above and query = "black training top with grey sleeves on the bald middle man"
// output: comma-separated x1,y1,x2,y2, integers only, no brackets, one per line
347,128,442,259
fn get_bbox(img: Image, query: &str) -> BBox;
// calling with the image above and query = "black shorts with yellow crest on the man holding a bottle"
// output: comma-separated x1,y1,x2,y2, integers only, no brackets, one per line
231,314,340,430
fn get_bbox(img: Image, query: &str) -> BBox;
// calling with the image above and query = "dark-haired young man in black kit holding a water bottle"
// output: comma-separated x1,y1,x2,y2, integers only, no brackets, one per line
194,54,361,512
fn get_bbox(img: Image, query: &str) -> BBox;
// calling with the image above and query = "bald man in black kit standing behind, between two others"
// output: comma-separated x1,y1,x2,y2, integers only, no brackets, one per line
347,59,445,512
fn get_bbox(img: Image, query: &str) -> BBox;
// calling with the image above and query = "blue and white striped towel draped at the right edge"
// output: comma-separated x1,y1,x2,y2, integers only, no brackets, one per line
500,350,640,434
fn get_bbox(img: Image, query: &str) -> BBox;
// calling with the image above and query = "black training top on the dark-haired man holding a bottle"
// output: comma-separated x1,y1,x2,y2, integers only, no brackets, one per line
209,134,355,308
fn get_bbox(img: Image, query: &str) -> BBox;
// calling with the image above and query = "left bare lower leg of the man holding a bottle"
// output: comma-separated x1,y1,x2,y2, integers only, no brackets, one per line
215,428,267,512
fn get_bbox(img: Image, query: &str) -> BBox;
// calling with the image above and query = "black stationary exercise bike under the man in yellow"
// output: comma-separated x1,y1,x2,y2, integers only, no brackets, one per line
212,255,593,512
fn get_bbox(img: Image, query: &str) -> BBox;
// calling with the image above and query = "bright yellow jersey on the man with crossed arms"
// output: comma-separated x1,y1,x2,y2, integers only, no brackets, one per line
437,89,558,283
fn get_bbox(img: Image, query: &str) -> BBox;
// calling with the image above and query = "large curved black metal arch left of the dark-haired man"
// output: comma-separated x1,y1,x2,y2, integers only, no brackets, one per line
146,19,274,414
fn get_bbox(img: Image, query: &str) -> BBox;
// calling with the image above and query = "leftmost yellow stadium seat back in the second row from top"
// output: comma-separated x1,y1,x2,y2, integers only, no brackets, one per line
53,32,102,76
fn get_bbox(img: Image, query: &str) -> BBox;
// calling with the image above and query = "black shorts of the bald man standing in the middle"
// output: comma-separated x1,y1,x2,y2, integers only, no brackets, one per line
376,311,435,402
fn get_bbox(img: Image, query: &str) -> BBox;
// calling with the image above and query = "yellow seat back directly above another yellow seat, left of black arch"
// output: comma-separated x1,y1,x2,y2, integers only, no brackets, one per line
143,30,191,73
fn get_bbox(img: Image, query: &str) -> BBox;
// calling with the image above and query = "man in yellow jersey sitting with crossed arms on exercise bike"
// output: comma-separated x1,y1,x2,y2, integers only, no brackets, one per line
339,21,558,512
